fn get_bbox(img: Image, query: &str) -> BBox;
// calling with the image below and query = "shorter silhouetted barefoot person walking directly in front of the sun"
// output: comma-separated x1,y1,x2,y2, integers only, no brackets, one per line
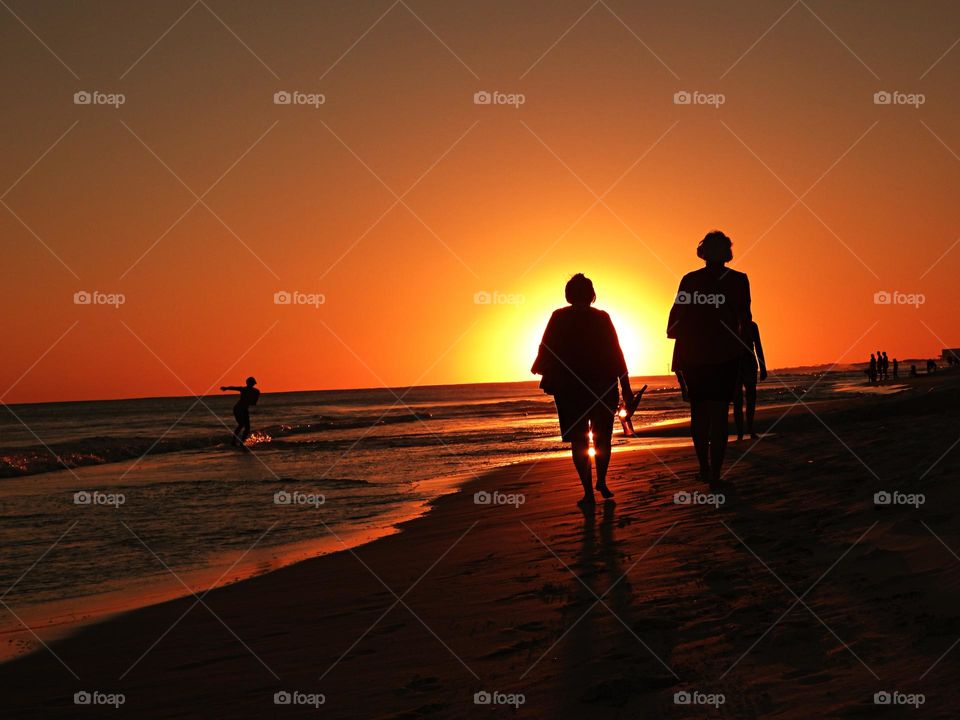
531,273,634,507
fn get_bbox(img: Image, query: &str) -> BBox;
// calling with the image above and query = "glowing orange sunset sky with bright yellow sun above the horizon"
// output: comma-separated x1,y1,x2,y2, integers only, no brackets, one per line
0,0,960,402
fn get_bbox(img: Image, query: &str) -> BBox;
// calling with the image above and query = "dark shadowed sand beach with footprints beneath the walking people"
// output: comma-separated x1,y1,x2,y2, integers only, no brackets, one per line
0,372,960,718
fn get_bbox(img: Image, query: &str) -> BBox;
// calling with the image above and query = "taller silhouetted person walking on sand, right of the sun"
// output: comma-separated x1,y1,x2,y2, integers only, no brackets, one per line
667,230,752,484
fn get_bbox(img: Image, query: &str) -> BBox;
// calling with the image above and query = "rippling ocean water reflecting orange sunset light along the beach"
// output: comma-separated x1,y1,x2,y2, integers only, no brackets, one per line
0,374,859,654
